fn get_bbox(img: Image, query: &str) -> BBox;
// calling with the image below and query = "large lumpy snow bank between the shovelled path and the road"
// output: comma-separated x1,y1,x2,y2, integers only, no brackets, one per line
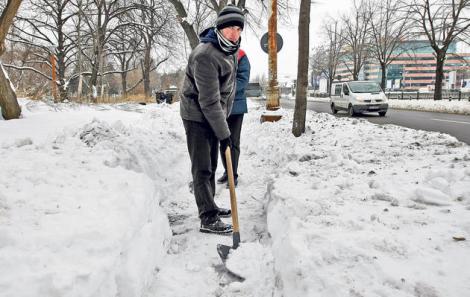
245,110,470,296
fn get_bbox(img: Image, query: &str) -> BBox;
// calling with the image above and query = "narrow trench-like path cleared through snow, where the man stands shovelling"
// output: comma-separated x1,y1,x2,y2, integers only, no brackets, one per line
145,103,275,297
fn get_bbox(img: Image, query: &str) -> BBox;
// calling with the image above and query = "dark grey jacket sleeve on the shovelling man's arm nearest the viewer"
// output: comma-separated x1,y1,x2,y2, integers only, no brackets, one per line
194,55,230,140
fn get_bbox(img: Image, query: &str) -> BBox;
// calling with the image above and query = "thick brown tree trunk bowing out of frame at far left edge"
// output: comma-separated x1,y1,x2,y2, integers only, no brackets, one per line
0,0,21,120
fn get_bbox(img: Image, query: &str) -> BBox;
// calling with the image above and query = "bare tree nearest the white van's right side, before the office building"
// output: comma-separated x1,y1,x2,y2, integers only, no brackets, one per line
369,0,410,89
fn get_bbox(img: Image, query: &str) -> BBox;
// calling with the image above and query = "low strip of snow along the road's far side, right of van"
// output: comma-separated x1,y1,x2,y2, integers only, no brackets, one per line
388,99,470,115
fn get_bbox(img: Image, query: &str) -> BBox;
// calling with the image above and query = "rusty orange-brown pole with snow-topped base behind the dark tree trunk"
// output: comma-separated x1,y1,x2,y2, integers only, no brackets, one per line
261,0,282,122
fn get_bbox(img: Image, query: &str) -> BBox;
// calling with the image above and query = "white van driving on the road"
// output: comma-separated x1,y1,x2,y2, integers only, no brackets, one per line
330,81,388,117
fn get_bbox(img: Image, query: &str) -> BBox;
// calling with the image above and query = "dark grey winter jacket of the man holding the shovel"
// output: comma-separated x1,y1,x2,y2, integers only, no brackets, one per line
180,28,236,140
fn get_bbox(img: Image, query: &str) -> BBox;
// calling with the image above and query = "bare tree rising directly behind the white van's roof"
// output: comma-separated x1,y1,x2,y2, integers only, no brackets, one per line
342,0,371,80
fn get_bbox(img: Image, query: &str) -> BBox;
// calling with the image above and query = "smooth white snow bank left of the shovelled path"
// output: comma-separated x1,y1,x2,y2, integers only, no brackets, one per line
0,102,176,296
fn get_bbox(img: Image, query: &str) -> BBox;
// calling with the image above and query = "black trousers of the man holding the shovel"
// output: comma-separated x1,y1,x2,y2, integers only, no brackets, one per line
183,120,219,220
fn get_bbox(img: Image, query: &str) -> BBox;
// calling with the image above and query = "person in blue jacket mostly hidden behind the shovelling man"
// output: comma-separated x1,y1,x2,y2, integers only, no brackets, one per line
217,49,251,186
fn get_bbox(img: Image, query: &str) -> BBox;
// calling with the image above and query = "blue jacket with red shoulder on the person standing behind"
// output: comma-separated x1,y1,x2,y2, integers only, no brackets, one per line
231,49,251,114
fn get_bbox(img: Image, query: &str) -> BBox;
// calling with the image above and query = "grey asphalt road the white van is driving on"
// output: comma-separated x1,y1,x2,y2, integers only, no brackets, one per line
281,100,470,144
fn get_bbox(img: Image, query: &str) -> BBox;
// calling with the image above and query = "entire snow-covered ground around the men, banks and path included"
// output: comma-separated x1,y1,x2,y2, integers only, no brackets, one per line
0,100,470,297
